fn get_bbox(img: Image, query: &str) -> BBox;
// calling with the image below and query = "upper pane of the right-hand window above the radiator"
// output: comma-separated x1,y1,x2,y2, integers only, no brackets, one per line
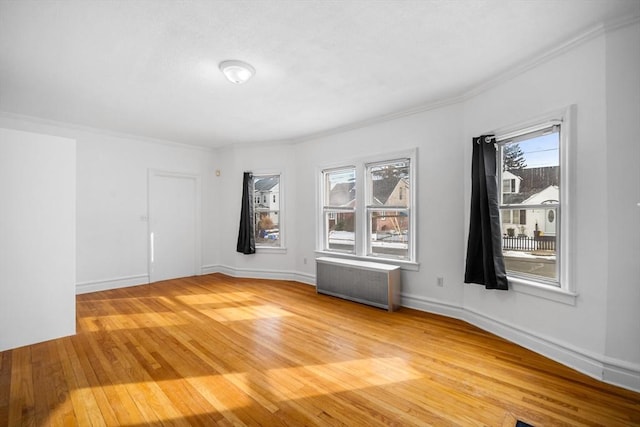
368,160,410,207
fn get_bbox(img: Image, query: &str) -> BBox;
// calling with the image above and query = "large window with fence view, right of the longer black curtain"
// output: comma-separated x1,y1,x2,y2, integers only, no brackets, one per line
498,123,563,286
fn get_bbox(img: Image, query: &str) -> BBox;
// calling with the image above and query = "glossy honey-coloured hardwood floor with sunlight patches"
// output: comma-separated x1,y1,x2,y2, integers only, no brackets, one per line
0,274,640,426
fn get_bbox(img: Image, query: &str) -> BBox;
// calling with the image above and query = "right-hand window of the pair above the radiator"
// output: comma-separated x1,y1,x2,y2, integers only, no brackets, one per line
366,159,411,259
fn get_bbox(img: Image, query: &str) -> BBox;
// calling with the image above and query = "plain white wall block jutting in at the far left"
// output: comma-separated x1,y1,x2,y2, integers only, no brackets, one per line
0,127,76,351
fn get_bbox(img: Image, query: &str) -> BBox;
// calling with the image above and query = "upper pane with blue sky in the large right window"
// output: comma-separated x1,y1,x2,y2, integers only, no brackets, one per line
501,130,560,205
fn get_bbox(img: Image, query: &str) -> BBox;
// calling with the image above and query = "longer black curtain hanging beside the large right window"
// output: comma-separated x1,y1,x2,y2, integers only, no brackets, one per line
464,135,509,290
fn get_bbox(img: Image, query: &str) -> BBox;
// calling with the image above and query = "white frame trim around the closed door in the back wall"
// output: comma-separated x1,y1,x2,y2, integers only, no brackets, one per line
147,169,202,283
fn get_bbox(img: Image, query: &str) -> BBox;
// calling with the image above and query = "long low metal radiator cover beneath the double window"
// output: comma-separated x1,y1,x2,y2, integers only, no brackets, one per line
316,257,400,311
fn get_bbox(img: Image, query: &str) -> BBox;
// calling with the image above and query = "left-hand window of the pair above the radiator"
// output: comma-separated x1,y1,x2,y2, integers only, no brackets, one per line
322,166,356,253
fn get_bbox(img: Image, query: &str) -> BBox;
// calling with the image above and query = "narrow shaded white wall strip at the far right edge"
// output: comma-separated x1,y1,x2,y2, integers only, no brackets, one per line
605,20,640,390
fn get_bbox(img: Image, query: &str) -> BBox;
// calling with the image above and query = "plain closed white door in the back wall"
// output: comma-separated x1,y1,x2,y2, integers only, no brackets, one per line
149,171,200,282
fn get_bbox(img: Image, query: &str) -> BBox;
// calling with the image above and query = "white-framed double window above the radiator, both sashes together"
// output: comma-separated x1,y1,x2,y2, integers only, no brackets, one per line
318,150,415,263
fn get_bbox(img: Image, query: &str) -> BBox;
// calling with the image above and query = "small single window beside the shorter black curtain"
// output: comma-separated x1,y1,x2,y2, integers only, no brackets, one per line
253,174,282,248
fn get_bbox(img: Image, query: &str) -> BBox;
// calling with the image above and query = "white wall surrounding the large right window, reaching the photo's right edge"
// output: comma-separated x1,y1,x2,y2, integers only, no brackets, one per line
464,24,640,389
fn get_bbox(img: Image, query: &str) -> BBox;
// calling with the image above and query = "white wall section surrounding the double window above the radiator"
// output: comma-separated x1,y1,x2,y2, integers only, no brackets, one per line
296,105,466,314
